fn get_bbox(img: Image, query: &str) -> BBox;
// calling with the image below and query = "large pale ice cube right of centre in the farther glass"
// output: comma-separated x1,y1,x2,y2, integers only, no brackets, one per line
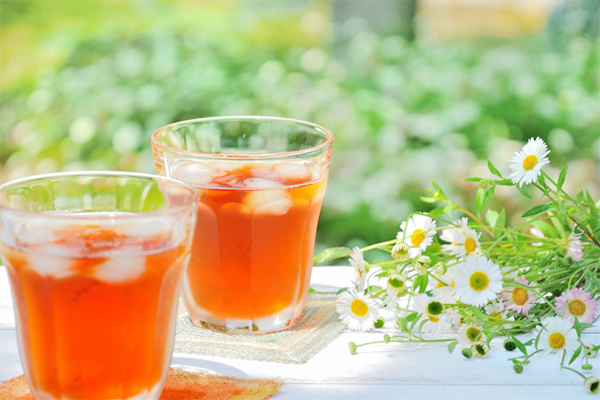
242,178,292,215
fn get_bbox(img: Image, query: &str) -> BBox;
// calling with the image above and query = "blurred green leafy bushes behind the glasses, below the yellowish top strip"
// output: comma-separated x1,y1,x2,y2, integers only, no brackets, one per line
0,4,600,245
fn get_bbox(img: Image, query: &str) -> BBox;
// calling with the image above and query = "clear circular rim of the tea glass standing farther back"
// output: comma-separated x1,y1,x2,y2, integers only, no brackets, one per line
150,115,334,160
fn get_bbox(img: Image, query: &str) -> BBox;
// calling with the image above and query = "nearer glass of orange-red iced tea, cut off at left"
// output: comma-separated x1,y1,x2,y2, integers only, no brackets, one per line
0,172,198,400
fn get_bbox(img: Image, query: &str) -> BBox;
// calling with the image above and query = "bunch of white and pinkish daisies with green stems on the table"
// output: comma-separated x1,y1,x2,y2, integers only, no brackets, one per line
315,138,600,393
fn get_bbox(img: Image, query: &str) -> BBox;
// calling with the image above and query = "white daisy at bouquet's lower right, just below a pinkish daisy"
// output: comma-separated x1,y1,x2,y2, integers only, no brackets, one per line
537,317,579,358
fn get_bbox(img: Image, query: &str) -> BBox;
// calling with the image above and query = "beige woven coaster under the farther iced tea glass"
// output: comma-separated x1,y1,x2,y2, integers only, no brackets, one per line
175,293,345,364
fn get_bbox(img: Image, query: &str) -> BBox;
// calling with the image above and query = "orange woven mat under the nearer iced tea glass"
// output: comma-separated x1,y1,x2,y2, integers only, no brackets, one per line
0,368,283,400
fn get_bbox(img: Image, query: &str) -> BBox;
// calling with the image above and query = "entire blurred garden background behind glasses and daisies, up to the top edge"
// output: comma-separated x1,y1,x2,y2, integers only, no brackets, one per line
0,0,600,253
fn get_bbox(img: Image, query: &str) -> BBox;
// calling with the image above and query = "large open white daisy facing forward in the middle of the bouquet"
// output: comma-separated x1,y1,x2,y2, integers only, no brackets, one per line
454,257,502,306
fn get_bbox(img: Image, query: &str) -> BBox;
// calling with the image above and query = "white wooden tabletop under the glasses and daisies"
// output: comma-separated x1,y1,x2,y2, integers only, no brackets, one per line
0,266,600,400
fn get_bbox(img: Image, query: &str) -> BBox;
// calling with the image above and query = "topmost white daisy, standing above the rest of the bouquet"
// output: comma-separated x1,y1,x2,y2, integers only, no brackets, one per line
508,137,550,187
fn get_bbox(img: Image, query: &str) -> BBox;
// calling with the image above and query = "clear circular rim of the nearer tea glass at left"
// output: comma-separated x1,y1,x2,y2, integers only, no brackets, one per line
0,171,200,220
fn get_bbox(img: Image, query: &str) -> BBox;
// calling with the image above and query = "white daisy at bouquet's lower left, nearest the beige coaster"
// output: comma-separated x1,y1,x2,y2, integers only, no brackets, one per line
335,289,379,331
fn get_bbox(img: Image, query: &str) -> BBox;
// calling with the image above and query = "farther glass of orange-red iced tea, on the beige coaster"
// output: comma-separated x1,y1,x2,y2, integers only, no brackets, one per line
152,117,333,333
